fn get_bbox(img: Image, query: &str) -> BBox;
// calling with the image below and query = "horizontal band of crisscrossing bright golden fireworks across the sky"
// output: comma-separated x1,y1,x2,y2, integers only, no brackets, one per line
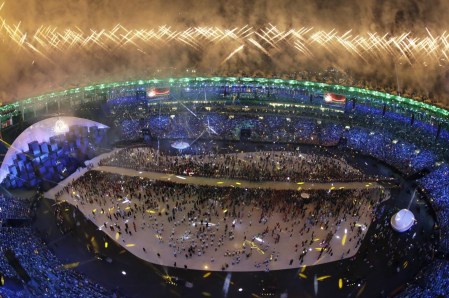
0,8,449,65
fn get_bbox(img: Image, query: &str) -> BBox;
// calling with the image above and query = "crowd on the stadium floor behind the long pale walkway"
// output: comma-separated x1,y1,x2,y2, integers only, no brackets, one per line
99,147,374,182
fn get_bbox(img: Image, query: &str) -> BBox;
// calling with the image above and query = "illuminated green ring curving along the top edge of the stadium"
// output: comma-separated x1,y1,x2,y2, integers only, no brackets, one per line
0,77,449,122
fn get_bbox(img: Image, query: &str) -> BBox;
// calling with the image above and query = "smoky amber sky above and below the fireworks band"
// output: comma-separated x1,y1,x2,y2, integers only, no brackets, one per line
0,0,449,102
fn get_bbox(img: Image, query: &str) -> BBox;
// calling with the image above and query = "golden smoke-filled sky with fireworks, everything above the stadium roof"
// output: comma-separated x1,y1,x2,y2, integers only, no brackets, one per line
0,0,449,104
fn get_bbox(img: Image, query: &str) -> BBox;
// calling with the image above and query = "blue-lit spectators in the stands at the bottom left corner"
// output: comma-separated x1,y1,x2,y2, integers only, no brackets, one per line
0,195,110,297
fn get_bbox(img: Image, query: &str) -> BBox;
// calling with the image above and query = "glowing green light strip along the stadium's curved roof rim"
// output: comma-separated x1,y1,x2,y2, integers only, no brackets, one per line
0,77,449,121
